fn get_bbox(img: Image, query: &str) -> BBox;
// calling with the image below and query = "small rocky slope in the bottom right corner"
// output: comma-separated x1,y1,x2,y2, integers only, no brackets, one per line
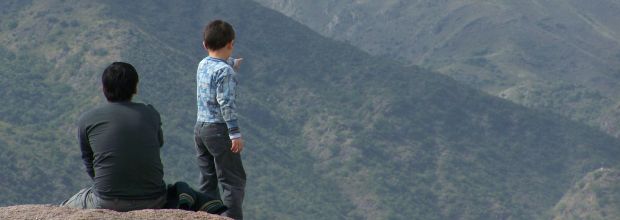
553,168,620,220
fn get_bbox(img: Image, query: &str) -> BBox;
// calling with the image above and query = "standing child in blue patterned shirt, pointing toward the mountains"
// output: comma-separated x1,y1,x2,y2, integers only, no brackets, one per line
194,20,246,219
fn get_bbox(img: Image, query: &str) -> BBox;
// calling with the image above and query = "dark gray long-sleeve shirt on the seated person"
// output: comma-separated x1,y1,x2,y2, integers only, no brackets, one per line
78,102,165,199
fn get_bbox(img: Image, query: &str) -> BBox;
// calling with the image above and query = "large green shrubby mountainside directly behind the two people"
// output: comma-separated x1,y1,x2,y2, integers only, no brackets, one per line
0,0,620,219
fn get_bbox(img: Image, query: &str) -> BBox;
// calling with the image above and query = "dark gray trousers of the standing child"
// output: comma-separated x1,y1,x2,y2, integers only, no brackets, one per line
194,122,246,219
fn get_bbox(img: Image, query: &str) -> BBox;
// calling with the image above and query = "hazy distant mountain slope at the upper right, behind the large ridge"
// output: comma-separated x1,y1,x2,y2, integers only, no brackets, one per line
255,0,620,137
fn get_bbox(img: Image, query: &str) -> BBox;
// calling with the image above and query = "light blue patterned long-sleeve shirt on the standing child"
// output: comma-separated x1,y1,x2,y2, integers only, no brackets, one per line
196,57,241,139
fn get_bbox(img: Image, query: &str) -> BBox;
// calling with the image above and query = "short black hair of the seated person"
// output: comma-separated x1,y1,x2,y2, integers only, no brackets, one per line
101,62,138,102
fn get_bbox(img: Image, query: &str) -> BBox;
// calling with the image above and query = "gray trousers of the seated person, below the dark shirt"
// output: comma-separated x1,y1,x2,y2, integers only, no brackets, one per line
61,187,166,212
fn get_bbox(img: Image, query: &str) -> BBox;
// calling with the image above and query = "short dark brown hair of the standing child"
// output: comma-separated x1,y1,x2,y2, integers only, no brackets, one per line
203,20,235,50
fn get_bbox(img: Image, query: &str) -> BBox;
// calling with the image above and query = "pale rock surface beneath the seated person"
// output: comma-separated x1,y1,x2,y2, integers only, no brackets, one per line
0,205,230,220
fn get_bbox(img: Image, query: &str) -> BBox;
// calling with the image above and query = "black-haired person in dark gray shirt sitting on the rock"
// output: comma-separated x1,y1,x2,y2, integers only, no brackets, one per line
62,62,225,213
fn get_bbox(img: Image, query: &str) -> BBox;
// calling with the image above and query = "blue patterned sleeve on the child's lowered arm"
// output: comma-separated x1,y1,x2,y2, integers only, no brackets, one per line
216,67,241,139
